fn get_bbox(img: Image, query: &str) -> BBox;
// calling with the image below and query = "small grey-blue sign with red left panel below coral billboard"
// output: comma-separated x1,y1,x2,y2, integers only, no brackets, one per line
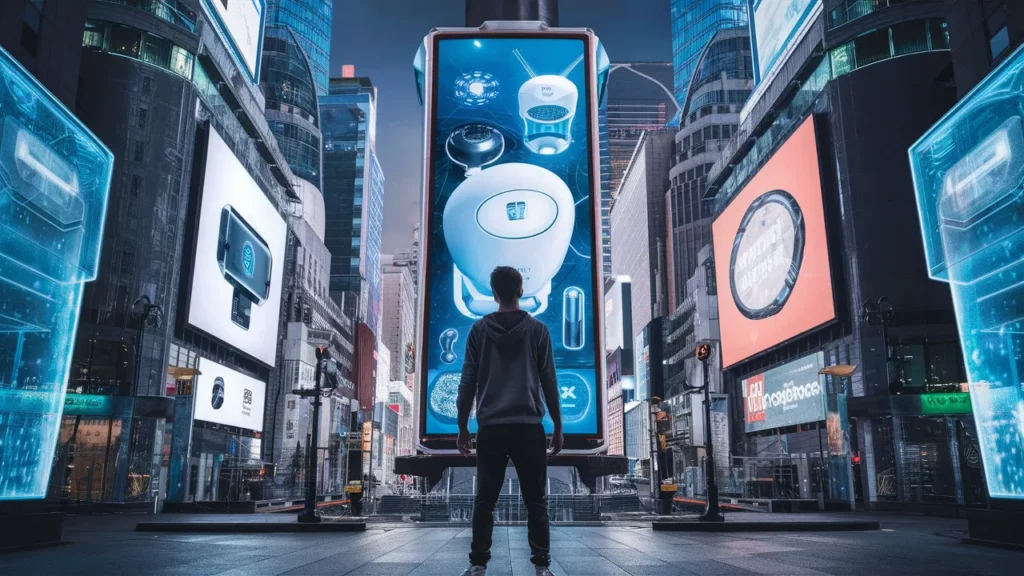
740,352,825,433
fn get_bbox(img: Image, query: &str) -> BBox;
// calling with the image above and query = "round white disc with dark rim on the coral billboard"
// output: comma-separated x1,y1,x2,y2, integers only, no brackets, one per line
729,190,806,320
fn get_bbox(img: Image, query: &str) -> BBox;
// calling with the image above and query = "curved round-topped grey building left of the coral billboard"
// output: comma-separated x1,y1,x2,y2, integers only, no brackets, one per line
665,28,754,311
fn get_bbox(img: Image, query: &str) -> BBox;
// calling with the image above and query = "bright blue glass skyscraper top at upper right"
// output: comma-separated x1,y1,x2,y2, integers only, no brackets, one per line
672,0,748,106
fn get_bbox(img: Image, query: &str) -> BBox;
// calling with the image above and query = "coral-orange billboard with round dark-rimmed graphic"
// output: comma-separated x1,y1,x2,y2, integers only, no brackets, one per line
712,118,836,367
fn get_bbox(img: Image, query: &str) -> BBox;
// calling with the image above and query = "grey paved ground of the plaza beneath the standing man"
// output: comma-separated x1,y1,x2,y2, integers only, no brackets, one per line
0,515,1024,576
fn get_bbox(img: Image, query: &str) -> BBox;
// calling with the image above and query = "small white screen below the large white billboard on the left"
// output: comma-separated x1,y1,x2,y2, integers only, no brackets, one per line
193,358,266,433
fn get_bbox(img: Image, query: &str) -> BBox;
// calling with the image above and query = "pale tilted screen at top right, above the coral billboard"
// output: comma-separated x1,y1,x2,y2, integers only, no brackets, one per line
749,0,821,82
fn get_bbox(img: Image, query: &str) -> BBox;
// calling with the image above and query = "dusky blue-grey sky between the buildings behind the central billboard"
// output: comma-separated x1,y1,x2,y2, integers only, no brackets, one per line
331,0,672,253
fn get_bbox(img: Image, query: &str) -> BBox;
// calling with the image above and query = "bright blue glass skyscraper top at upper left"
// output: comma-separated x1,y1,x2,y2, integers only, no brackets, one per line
266,0,334,95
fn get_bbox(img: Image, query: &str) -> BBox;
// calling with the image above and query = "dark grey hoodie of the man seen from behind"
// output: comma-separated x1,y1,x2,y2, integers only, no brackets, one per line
458,311,558,426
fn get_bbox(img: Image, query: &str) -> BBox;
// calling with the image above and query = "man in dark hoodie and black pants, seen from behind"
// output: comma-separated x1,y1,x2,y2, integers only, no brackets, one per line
457,266,562,576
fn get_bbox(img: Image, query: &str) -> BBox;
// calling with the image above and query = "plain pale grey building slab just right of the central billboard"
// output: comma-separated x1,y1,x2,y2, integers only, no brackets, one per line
611,130,674,350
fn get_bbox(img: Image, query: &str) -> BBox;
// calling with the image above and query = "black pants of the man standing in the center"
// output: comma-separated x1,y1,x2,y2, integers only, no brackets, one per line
469,424,551,566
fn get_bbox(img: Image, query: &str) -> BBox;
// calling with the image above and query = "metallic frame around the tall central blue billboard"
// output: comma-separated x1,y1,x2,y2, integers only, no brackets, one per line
414,22,608,454
